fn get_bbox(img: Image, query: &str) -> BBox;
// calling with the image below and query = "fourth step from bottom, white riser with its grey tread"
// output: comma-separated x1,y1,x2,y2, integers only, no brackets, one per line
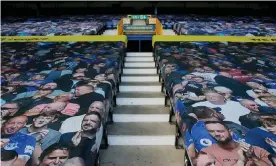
119,82,161,92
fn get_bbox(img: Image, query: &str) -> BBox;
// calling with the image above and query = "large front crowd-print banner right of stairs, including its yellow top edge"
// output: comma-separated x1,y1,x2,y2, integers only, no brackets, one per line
153,36,276,166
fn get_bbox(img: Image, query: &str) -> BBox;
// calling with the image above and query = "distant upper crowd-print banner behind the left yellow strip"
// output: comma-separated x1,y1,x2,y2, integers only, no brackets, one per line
1,15,124,36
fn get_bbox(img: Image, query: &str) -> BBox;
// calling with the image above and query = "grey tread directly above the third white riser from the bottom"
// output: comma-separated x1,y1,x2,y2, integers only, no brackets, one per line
117,92,165,99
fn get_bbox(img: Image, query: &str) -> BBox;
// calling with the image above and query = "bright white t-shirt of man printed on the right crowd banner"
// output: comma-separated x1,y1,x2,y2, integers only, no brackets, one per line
192,101,250,124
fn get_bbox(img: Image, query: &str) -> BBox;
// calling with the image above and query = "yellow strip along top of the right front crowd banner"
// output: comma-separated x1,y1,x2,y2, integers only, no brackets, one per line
152,35,276,46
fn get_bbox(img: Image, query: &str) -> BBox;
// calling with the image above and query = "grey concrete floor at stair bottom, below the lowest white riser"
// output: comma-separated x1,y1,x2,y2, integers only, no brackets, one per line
100,146,184,166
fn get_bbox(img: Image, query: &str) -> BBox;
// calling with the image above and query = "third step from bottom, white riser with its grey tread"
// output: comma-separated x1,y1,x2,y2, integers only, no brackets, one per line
116,92,165,105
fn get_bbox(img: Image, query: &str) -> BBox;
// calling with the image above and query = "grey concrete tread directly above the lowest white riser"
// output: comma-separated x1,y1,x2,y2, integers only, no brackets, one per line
107,122,175,136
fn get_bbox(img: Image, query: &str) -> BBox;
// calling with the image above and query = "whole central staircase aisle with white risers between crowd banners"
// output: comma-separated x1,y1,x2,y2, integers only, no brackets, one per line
100,52,184,166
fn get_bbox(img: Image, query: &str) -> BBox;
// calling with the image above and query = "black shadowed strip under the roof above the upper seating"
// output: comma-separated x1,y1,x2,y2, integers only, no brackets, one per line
1,1,275,16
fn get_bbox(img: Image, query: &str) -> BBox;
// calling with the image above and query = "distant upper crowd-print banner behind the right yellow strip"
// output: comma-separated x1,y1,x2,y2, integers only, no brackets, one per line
157,14,276,36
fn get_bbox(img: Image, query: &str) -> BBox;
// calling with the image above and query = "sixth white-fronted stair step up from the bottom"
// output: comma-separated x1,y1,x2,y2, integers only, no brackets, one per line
123,67,157,74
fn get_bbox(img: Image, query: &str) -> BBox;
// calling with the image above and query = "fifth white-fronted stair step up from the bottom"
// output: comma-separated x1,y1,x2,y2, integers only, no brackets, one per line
121,74,159,83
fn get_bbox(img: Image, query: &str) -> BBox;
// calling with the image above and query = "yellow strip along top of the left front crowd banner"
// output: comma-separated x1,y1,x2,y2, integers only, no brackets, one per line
1,35,127,44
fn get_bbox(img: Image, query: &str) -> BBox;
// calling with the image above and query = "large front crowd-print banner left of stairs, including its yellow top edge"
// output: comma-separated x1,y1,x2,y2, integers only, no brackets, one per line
1,36,126,166
